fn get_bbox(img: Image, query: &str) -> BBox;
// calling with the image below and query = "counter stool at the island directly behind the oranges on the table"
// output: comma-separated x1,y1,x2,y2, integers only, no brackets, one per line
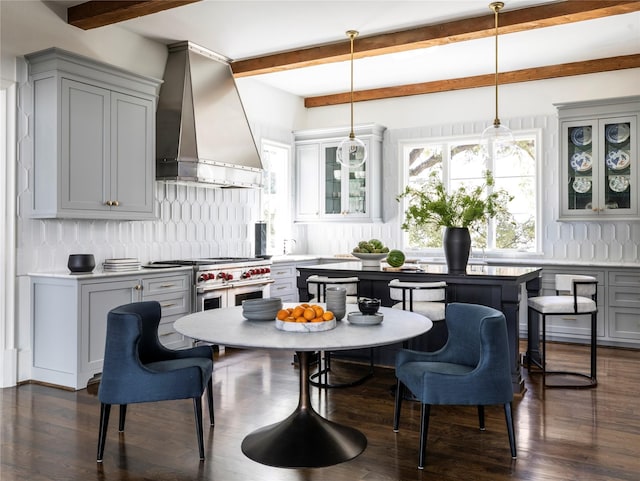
307,275,373,389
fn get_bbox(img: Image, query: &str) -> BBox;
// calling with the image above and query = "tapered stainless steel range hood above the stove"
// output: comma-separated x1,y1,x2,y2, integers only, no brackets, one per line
156,42,262,188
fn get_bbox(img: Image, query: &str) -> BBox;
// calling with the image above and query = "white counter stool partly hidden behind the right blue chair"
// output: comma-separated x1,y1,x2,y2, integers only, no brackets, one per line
389,279,447,351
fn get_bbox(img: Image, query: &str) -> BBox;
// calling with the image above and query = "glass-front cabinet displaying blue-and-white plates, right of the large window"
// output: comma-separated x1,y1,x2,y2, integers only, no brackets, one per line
558,97,640,220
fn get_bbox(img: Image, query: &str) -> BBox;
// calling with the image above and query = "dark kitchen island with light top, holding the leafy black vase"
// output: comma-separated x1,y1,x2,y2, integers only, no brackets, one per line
297,261,542,393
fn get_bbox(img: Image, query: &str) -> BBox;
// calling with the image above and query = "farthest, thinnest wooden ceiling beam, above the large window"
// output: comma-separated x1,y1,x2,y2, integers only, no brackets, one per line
304,54,640,108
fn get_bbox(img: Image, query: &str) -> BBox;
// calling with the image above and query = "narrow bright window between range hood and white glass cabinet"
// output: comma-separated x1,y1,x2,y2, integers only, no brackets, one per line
260,140,293,255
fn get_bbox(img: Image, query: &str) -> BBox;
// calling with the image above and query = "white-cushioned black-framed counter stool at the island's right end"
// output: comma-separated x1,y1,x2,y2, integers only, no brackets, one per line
527,274,598,388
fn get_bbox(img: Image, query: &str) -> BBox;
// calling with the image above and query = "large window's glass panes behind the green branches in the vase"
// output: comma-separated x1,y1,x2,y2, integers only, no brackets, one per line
401,133,538,252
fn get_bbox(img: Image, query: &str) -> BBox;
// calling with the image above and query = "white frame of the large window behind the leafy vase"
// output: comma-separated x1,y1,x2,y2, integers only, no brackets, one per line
397,128,544,257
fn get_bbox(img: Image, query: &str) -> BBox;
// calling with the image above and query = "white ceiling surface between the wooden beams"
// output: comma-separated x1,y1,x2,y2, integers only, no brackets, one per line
63,0,640,97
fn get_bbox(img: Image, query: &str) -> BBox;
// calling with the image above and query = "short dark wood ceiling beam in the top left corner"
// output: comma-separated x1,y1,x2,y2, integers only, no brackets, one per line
67,0,200,30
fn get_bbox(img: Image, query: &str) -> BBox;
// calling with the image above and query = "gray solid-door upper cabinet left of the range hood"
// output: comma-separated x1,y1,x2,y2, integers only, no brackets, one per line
26,48,160,219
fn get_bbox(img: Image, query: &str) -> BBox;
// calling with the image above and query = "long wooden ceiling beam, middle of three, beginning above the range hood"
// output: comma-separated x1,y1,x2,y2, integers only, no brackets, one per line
231,0,640,77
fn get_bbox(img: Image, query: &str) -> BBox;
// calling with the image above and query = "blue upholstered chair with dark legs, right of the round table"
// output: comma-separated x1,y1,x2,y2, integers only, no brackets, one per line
393,303,516,469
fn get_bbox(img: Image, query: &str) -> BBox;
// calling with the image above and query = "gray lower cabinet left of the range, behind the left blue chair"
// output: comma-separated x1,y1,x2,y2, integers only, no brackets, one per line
31,271,191,389
